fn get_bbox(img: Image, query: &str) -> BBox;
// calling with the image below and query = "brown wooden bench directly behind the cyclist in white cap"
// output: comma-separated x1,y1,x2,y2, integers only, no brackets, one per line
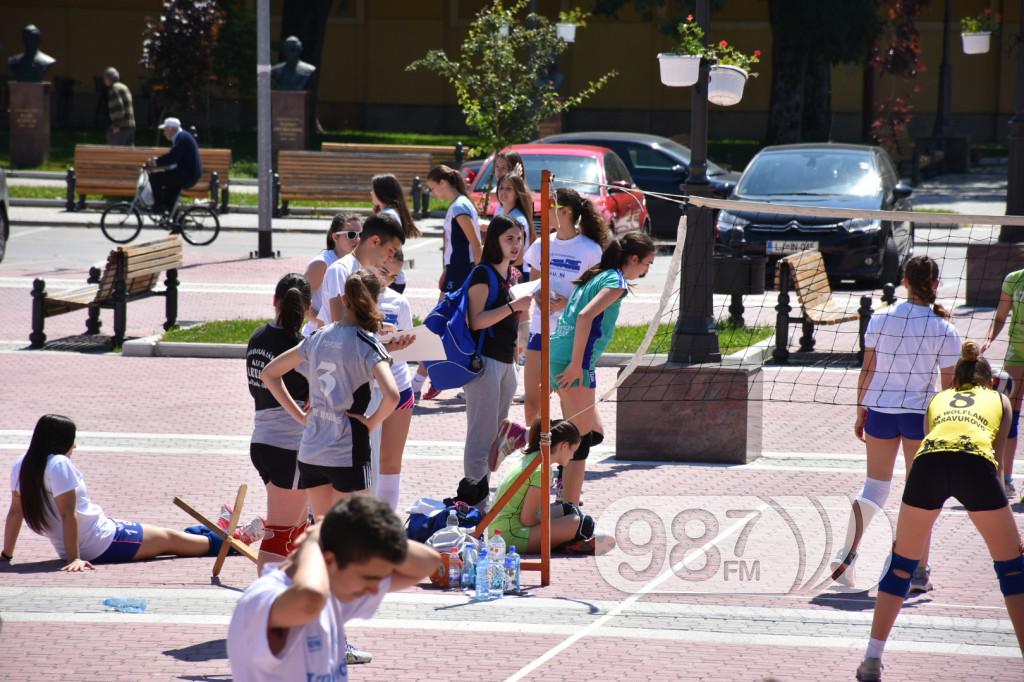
67,144,231,213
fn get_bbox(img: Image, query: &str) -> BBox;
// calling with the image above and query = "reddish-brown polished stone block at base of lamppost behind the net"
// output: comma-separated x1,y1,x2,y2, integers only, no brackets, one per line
615,361,762,464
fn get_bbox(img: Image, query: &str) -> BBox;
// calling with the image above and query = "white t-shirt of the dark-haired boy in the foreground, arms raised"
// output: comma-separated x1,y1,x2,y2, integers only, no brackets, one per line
227,565,391,682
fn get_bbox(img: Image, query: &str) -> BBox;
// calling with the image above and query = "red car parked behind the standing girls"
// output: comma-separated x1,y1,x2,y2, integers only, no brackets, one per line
470,144,650,236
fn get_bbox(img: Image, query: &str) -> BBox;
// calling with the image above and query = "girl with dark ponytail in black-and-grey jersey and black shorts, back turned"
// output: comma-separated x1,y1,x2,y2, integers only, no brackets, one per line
245,272,311,576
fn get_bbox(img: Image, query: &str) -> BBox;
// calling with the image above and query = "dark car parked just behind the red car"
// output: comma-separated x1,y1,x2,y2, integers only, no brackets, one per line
539,131,739,238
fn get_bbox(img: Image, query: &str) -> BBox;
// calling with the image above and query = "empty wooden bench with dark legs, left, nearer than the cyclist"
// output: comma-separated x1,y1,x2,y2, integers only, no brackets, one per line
29,237,182,348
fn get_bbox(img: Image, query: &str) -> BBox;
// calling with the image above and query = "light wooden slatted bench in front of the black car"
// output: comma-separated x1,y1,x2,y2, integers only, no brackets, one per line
772,250,894,363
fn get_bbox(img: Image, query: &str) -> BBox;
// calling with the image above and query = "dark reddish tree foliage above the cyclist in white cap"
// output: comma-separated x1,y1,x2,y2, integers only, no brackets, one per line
139,0,223,117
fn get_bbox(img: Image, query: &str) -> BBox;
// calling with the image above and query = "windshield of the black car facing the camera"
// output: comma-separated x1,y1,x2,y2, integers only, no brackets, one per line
736,150,882,197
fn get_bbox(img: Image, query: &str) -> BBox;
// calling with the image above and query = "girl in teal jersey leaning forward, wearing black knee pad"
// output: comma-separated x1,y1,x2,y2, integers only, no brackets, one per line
551,232,656,512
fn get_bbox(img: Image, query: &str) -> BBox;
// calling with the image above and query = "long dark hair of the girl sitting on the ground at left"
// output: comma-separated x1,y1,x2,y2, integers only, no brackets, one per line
17,415,78,535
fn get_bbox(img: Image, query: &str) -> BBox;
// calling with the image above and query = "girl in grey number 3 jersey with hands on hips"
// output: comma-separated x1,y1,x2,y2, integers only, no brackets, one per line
260,270,398,518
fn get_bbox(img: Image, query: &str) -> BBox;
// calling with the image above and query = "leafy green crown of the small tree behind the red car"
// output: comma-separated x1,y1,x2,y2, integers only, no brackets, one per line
407,0,616,153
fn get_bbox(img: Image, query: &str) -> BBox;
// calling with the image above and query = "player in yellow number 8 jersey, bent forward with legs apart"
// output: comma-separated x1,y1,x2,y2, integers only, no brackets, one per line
857,341,1024,682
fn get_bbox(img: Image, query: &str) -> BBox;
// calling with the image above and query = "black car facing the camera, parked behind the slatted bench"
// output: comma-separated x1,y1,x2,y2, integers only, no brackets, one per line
716,143,913,286
